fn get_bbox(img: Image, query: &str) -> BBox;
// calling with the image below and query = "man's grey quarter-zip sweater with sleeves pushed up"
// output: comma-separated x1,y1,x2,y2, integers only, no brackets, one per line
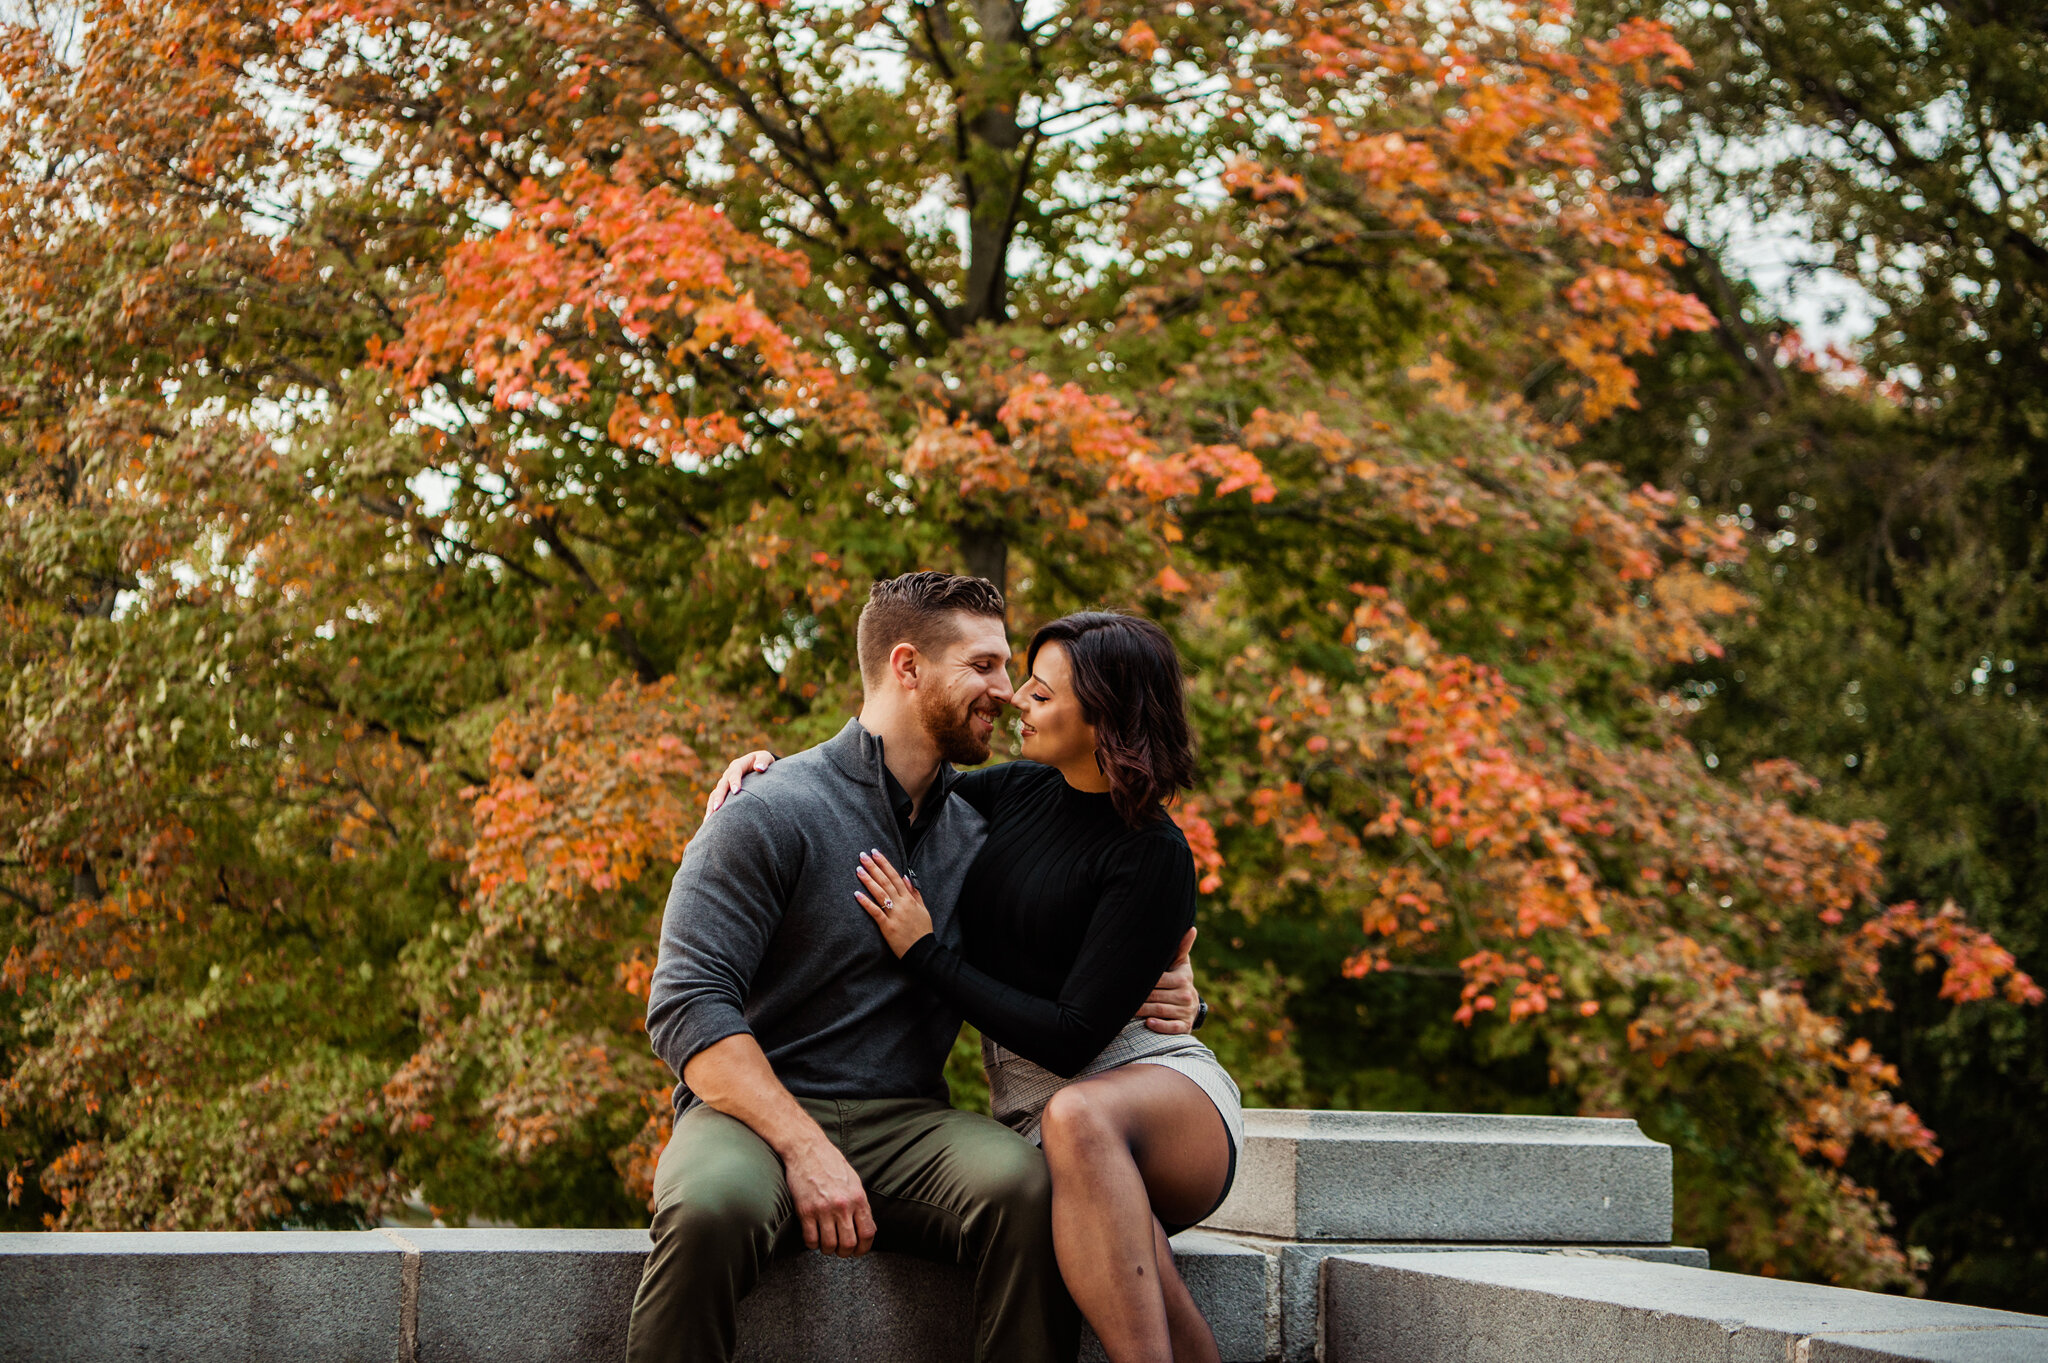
647,720,987,1115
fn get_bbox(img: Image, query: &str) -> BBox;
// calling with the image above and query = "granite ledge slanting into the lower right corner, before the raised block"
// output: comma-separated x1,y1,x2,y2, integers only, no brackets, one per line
1323,1250,2048,1363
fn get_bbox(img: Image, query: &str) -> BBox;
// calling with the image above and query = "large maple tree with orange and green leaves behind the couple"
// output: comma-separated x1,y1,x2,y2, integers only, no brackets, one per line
0,0,2040,1283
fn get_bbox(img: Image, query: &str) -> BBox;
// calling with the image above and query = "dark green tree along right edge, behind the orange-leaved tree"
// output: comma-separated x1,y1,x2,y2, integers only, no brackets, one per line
1585,2,2048,1312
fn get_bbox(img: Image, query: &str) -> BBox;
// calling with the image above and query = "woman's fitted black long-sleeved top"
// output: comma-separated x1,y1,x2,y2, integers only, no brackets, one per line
903,761,1196,1076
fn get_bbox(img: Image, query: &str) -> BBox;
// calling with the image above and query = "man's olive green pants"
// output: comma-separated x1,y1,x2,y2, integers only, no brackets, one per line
627,1099,1081,1363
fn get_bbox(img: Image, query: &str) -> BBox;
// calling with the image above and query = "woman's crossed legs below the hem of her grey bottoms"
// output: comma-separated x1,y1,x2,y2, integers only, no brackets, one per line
1040,1064,1231,1363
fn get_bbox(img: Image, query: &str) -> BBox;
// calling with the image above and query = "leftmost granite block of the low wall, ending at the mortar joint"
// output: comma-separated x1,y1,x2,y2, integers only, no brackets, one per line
0,1230,403,1363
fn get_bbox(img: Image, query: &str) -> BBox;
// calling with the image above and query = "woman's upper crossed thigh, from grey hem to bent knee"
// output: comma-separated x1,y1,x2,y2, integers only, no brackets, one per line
1044,1064,1231,1226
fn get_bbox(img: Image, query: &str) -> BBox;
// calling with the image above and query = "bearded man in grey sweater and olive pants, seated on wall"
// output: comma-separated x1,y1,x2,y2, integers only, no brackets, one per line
627,573,1194,1363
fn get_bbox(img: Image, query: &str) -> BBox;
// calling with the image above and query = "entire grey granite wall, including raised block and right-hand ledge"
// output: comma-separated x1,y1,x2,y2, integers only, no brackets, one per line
0,1111,2048,1363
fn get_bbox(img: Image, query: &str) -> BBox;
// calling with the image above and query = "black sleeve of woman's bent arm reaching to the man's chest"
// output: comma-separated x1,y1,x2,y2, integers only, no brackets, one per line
903,829,1196,1079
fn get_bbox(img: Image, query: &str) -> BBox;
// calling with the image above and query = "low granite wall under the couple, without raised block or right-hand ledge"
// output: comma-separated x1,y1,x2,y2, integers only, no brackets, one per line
0,1230,1272,1363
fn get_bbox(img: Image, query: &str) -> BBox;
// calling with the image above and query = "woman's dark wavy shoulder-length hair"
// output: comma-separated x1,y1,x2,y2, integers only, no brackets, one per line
1024,610,1194,829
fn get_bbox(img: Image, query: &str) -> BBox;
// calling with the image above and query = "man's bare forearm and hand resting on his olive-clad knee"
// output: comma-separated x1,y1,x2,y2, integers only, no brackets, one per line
682,1031,874,1259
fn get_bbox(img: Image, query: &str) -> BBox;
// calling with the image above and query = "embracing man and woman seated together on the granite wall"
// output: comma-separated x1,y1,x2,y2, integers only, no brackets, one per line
627,573,1243,1363
